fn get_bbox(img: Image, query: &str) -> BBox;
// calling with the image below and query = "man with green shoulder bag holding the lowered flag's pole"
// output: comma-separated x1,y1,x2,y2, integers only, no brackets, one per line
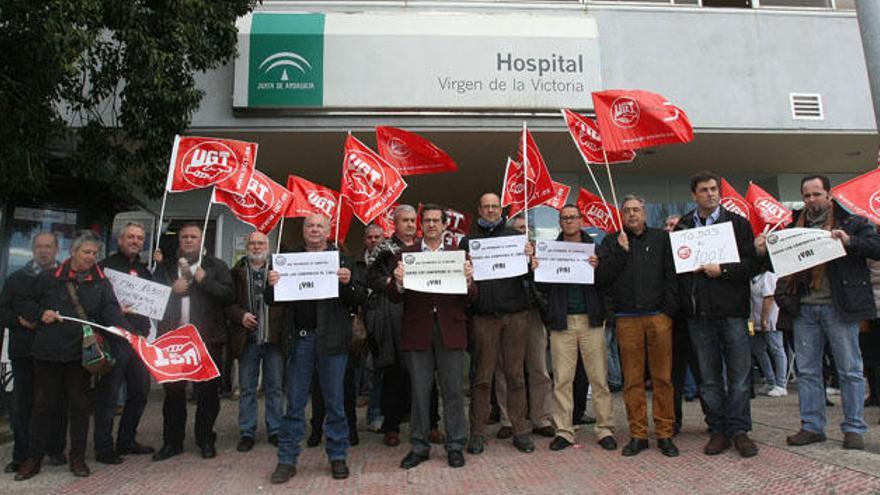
15,231,130,480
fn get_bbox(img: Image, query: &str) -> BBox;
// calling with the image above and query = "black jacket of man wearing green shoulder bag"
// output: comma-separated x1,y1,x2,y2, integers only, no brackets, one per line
18,260,131,363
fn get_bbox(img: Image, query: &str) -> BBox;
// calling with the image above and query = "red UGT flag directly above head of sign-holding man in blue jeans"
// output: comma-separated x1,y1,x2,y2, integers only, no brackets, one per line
284,175,352,242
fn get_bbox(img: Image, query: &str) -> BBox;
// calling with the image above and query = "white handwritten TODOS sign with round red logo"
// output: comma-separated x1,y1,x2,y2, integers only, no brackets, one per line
669,222,739,273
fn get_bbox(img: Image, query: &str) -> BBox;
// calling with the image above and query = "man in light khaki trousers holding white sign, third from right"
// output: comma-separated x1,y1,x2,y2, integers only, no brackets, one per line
532,204,617,450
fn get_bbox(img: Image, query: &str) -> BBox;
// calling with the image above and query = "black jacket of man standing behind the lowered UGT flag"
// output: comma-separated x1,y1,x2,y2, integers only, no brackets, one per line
156,254,232,344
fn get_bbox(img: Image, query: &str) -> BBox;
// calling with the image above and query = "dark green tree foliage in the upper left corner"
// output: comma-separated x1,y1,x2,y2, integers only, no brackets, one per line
0,0,257,197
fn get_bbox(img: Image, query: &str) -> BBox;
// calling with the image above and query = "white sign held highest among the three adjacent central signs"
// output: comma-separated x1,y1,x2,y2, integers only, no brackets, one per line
468,235,529,280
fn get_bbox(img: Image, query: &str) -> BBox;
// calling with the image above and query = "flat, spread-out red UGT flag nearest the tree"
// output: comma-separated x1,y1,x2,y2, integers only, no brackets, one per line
165,136,257,199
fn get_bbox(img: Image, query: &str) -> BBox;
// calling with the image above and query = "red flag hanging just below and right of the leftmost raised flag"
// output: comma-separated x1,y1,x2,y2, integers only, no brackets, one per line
213,170,293,234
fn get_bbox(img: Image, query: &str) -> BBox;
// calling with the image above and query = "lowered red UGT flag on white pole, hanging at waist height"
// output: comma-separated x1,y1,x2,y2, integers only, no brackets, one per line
108,325,220,383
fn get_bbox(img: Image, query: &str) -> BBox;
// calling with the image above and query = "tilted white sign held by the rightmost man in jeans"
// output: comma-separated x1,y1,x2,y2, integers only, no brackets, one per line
767,228,846,277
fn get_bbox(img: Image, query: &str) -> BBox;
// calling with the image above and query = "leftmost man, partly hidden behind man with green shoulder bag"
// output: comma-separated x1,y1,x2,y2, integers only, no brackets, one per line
0,232,67,473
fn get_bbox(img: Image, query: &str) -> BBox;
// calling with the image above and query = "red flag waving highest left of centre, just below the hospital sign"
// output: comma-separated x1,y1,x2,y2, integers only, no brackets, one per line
376,126,458,175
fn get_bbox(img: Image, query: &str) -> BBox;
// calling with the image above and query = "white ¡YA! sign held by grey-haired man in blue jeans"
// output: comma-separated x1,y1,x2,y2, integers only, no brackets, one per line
272,251,339,301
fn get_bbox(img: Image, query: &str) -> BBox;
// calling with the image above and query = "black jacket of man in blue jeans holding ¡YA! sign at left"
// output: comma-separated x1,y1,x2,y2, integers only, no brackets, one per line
265,246,367,356
